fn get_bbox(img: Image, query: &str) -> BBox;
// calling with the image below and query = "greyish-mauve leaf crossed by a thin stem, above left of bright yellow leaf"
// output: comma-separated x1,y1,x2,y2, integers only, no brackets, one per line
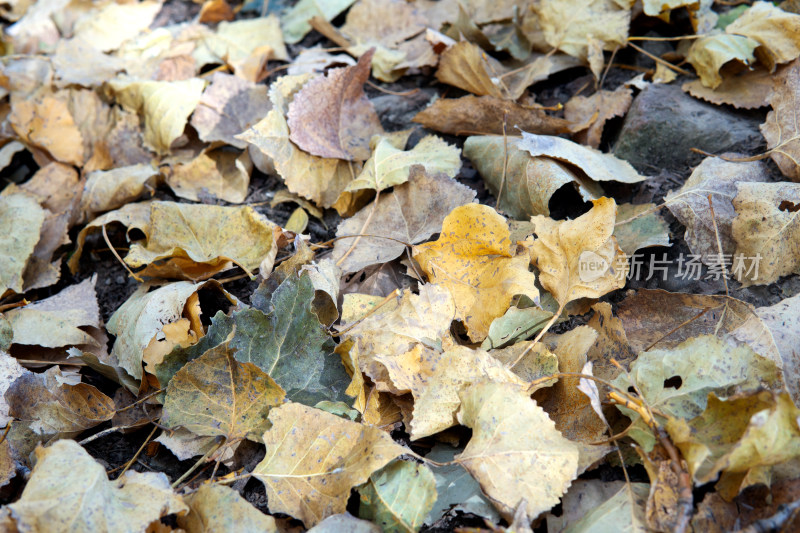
332,168,475,272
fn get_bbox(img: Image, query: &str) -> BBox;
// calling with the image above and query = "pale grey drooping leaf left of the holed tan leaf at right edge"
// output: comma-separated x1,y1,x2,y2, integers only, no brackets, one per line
665,154,769,264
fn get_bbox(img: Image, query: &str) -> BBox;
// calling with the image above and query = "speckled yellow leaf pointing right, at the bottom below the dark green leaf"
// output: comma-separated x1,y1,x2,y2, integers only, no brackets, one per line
253,403,407,527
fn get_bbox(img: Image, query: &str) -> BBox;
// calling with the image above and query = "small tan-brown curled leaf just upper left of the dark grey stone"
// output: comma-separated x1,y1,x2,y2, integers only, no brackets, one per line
564,85,633,148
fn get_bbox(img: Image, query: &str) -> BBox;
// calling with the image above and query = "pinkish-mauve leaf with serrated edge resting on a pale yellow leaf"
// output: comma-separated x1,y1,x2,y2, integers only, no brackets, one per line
288,53,383,161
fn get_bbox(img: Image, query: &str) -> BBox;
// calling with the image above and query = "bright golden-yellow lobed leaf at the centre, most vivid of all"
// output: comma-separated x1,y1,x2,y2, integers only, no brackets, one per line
413,204,539,342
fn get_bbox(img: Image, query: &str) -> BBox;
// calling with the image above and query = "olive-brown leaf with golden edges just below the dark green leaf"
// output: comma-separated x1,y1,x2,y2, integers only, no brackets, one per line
161,344,285,445
